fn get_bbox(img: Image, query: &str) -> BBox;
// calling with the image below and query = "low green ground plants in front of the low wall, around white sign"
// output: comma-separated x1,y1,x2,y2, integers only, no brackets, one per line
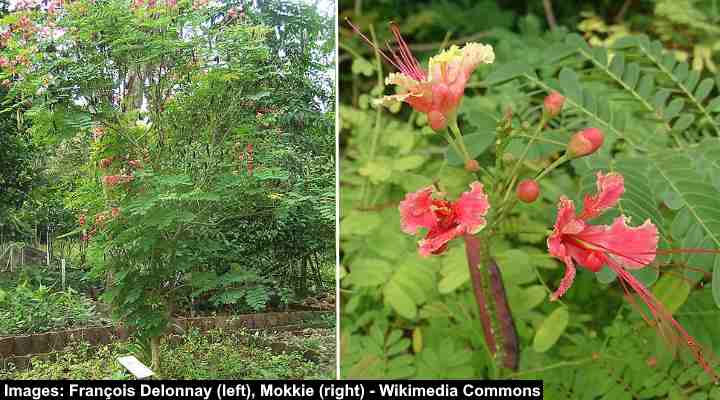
0,331,335,379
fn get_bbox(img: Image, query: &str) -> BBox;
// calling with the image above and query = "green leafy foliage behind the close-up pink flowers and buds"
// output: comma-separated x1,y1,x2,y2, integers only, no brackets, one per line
340,1,720,399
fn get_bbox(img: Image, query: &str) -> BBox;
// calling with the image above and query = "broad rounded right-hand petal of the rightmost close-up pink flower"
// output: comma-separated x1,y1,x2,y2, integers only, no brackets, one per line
605,216,659,269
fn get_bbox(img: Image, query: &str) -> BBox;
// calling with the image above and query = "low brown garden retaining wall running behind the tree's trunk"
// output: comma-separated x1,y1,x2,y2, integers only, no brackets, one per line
0,311,324,369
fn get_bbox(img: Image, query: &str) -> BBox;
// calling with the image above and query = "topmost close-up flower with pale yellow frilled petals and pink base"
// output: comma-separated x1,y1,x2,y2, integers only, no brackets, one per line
348,21,495,131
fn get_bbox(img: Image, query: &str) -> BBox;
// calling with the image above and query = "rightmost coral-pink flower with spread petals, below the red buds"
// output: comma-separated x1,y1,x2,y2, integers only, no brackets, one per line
547,172,658,300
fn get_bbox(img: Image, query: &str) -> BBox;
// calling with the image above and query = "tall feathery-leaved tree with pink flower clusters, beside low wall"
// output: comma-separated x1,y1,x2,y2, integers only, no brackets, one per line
1,0,333,369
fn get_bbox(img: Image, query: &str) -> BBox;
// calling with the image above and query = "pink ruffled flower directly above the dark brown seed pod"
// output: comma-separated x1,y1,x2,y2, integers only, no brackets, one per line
399,182,490,257
